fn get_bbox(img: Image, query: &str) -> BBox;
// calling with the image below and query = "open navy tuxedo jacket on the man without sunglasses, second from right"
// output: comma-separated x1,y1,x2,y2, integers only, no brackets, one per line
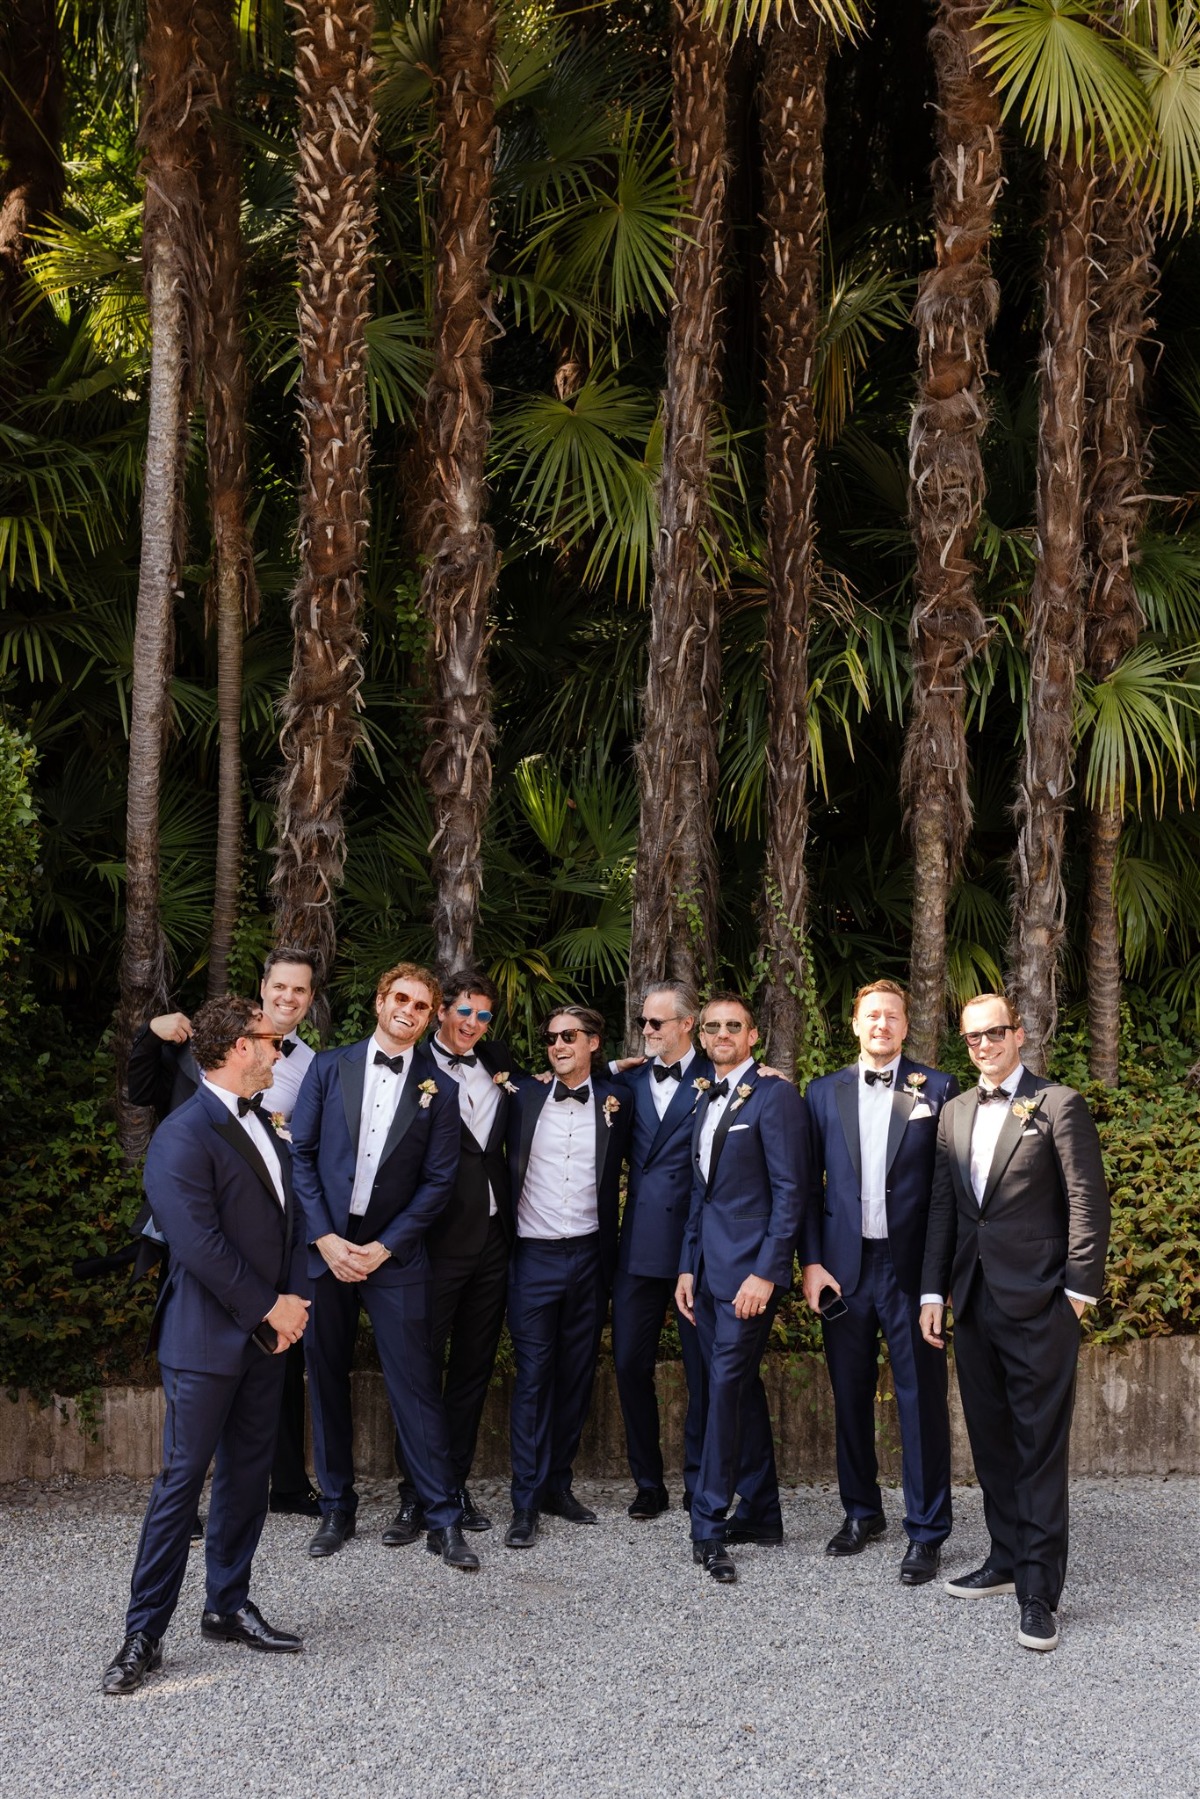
801,1056,959,1297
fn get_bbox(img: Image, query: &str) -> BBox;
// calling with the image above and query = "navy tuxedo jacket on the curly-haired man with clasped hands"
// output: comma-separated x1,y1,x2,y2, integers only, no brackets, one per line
291,1038,461,1286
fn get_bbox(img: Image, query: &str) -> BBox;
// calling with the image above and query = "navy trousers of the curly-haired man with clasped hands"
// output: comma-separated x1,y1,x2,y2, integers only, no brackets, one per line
304,1274,462,1531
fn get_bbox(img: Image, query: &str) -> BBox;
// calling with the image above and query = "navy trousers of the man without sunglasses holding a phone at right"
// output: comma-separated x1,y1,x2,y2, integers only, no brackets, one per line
820,1238,952,1544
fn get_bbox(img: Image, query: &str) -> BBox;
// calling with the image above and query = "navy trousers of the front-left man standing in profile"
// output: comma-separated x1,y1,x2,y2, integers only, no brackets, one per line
124,1344,284,1637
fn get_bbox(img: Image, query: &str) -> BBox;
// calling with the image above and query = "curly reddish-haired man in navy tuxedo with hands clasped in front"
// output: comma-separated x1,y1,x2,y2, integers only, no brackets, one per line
291,962,479,1571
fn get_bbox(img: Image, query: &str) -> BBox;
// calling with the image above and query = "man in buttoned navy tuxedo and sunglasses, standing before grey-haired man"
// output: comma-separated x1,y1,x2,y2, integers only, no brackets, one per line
675,993,810,1581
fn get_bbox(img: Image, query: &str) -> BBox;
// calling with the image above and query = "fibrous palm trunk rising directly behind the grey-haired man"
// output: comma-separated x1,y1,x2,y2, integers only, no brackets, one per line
628,0,729,1047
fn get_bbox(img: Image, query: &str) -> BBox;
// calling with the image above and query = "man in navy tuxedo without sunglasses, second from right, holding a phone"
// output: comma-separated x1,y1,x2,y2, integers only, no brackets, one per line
801,980,959,1587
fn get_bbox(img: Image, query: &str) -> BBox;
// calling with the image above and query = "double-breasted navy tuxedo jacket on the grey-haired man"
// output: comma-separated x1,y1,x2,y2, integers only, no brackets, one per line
617,1056,712,1281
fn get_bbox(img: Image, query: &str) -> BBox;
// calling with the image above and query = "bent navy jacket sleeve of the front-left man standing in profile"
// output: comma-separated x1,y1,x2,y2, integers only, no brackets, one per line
144,1123,279,1335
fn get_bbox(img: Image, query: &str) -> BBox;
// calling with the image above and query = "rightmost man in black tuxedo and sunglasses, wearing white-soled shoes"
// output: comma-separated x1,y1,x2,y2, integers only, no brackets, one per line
921,993,1110,1651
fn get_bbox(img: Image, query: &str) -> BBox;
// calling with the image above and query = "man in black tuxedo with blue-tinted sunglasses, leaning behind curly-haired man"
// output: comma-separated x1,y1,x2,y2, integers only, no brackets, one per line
383,968,524,1545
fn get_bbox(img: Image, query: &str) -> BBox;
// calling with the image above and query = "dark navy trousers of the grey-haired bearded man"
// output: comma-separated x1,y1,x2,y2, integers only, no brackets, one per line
612,1268,703,1495
